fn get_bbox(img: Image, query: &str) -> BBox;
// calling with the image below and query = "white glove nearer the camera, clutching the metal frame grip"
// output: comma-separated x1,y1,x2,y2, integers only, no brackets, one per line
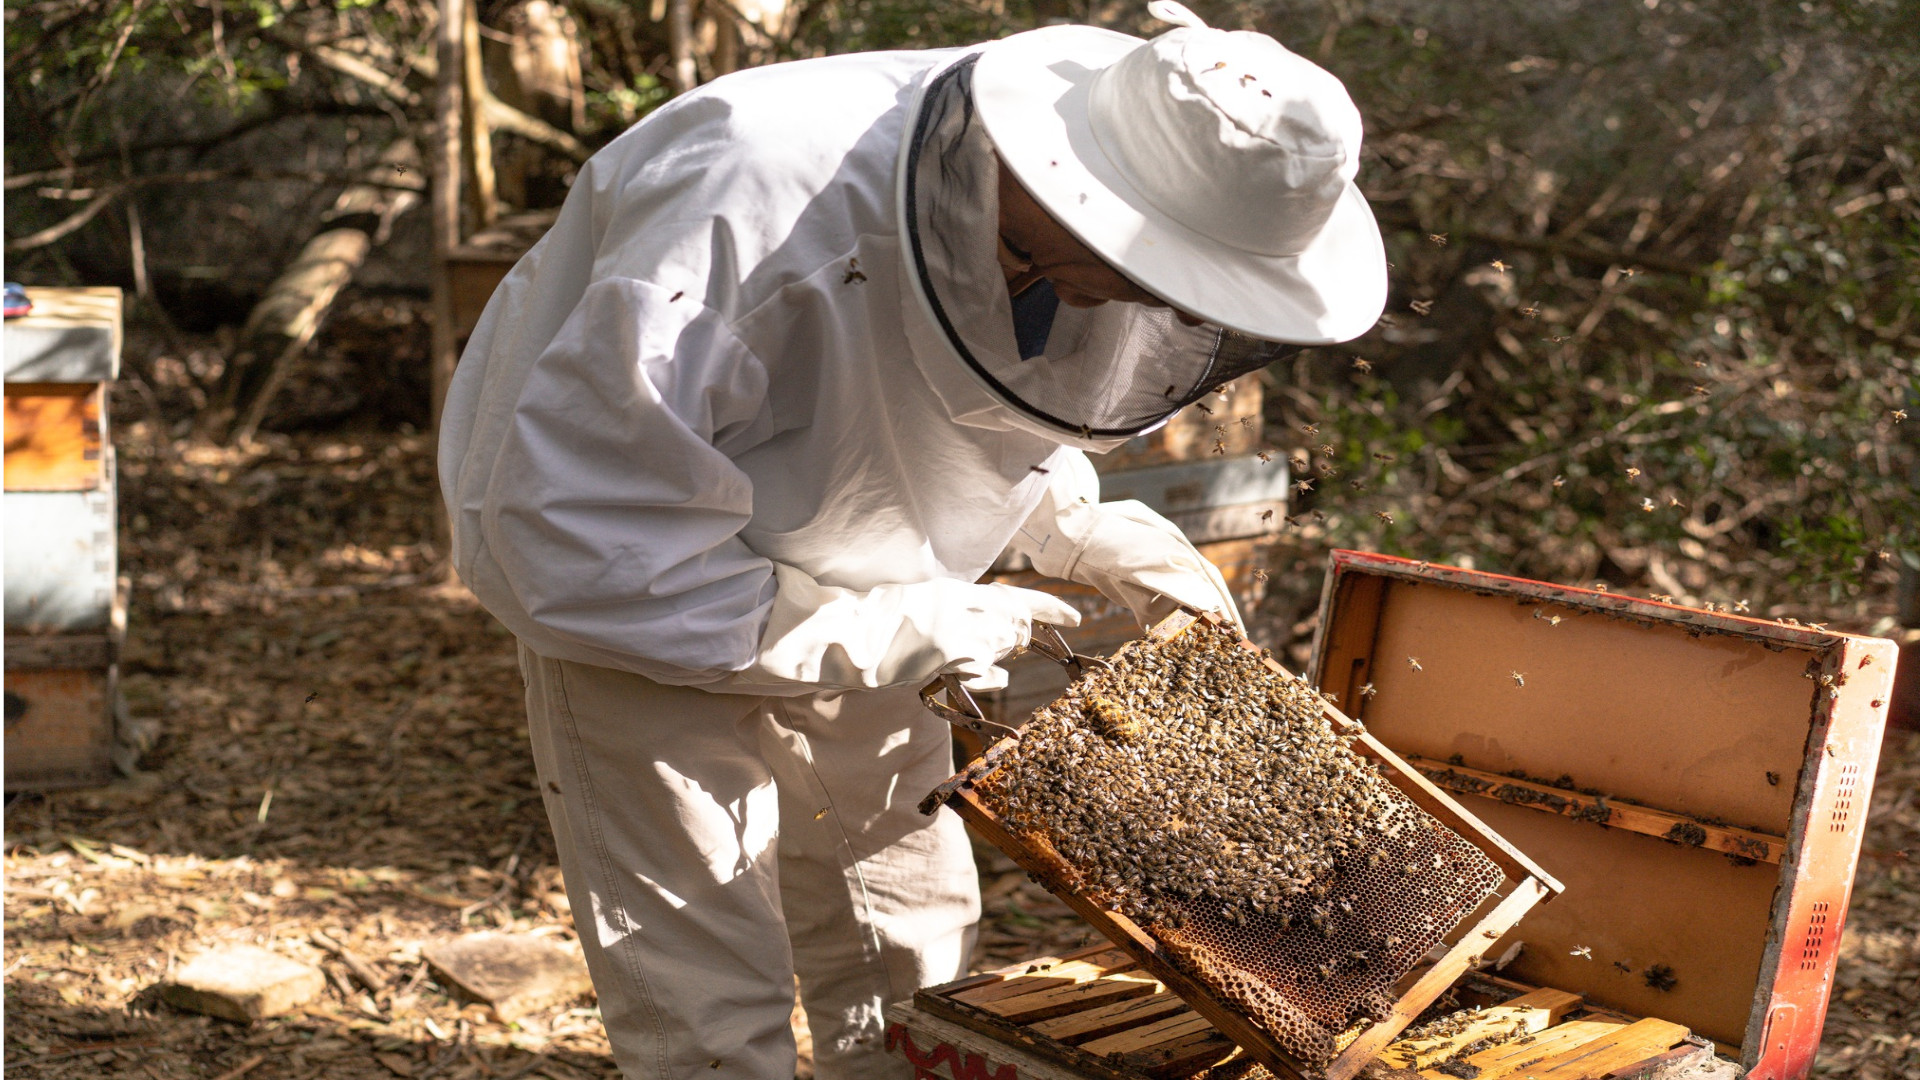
716,563,1079,694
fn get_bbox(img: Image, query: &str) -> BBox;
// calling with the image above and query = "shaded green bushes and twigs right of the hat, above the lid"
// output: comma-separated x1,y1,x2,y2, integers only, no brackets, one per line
1225,0,1920,611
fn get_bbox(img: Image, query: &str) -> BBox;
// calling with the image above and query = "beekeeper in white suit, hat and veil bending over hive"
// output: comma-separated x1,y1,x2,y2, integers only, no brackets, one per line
440,4,1386,1080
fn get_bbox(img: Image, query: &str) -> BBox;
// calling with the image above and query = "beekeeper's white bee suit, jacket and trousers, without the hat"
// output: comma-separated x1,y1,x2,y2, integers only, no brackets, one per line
440,42,1219,1080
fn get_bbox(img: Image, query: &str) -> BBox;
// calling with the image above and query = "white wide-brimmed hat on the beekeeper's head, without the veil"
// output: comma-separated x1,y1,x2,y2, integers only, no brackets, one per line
973,0,1386,344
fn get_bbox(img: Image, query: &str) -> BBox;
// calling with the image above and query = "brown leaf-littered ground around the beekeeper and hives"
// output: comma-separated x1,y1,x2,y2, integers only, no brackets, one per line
4,417,1920,1080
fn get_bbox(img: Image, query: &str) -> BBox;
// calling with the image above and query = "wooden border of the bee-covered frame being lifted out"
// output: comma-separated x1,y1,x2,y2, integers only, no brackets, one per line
920,611,1563,1080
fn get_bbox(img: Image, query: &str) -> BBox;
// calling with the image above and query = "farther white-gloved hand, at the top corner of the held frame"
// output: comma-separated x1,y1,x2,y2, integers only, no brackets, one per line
1014,454,1240,628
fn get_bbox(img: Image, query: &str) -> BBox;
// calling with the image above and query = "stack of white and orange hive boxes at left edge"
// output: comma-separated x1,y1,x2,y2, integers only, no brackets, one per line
4,288,125,790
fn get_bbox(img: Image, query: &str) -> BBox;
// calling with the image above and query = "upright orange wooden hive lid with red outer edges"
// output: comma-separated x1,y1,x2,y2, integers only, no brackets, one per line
1311,552,1895,1076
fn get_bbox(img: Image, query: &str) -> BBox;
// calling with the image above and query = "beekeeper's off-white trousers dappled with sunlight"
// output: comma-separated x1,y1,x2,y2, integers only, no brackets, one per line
520,646,979,1080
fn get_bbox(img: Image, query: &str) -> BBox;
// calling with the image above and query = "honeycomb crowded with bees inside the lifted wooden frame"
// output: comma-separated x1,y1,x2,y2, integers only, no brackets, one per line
975,621,1503,1067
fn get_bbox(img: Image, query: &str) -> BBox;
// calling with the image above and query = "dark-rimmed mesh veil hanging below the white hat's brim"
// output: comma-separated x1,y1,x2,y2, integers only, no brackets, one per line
904,58,1298,438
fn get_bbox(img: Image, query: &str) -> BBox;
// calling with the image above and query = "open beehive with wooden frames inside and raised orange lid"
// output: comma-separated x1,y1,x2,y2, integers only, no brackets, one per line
889,552,1895,1080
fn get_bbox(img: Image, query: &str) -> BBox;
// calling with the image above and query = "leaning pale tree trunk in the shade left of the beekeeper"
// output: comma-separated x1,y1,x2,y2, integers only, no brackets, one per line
209,135,420,442
